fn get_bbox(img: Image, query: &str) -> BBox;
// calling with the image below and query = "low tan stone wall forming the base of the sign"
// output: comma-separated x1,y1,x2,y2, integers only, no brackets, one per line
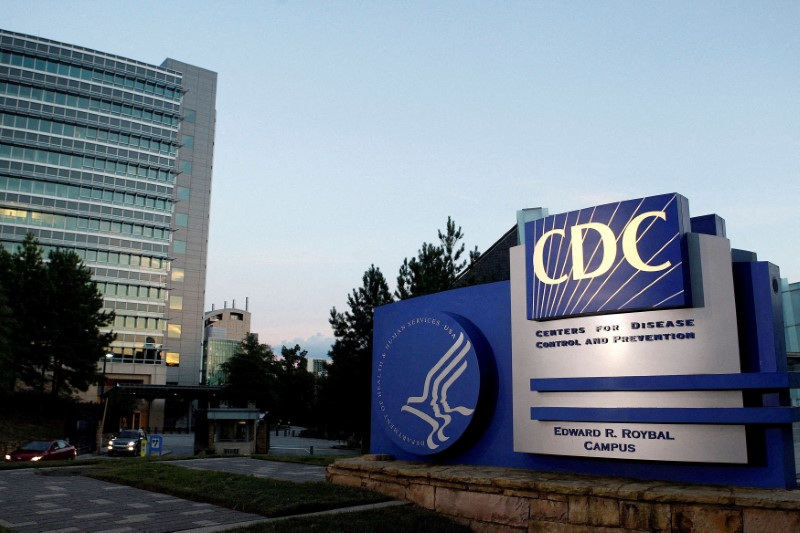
327,455,800,533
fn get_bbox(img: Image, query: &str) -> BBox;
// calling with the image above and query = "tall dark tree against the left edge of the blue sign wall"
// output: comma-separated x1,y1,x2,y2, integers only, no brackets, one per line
320,265,393,451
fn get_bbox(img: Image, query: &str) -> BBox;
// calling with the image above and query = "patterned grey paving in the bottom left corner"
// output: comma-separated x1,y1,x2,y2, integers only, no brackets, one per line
0,469,263,533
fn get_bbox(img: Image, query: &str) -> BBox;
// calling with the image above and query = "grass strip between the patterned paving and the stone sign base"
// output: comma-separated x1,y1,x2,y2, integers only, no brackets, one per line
86,461,388,517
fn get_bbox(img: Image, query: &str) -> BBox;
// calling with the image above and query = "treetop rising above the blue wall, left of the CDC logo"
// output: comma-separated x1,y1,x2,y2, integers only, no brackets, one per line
395,217,480,300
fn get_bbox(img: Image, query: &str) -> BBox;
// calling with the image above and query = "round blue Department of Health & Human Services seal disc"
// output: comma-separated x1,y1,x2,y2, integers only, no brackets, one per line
373,312,481,455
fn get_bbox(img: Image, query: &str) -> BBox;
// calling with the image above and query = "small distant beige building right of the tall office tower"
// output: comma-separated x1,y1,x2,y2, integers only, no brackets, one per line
203,302,250,385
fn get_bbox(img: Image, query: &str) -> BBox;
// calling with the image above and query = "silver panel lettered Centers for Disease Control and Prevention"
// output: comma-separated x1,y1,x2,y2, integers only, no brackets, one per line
511,234,747,463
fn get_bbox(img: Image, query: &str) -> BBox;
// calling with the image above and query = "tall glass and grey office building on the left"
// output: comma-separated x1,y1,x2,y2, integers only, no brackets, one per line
0,30,216,385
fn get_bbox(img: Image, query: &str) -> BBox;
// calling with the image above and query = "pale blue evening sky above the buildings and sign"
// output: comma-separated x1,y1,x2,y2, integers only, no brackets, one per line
0,0,800,357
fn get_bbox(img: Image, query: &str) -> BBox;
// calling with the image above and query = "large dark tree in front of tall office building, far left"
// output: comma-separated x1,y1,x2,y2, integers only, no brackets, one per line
0,234,114,398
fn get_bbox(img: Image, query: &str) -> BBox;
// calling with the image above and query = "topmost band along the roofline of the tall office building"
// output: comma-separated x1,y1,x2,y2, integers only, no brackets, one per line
0,30,181,85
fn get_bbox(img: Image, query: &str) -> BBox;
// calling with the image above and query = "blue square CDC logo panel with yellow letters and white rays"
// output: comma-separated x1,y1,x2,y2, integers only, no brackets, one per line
525,194,690,320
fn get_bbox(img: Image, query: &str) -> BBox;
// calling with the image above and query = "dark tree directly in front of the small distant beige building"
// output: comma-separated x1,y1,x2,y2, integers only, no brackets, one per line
220,333,276,410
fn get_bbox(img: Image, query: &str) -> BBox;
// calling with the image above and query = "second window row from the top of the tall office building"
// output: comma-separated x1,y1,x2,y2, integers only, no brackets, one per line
0,52,181,101
